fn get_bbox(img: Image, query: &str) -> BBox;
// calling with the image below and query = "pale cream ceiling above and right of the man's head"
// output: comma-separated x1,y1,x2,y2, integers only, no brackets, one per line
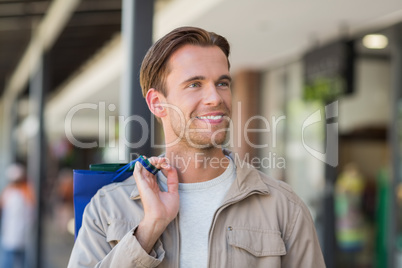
181,0,402,69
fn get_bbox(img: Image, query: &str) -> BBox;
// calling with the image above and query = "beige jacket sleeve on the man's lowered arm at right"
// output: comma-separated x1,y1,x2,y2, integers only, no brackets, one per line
282,201,326,268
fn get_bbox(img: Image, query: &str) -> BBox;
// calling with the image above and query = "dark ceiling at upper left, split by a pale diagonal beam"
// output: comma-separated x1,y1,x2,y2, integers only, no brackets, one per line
0,0,121,95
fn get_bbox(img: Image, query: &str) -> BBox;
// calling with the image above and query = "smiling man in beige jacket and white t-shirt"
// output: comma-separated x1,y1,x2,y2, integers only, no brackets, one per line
69,27,325,268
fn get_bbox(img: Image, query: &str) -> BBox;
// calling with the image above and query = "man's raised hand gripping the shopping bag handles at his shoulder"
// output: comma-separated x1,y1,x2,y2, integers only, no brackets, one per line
134,157,179,253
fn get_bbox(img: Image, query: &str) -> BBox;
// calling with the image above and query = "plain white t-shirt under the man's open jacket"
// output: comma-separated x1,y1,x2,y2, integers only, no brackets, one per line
157,157,236,268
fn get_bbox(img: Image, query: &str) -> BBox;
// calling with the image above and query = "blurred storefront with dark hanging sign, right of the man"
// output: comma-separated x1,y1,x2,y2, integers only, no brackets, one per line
258,21,402,267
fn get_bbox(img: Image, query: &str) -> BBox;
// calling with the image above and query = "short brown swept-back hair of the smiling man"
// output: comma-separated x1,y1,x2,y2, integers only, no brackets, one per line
140,27,230,97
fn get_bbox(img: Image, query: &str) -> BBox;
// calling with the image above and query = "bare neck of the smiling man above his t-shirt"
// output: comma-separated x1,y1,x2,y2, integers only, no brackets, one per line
166,146,230,183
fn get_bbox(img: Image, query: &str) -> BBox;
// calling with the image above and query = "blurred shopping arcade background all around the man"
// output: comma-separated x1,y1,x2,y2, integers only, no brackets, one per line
0,0,402,267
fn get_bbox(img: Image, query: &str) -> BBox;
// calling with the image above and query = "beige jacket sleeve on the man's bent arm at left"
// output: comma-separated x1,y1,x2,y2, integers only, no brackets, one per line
68,196,165,268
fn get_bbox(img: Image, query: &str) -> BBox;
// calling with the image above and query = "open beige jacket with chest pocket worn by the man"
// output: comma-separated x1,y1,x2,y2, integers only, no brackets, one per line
68,153,325,268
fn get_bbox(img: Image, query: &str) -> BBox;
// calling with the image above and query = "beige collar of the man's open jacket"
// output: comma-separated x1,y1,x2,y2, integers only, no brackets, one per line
130,149,270,202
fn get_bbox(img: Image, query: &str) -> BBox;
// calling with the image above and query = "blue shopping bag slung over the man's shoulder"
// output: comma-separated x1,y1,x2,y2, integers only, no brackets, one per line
73,156,158,237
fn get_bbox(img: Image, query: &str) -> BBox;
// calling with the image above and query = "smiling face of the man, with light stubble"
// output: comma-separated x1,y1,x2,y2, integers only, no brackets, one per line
165,45,232,148
